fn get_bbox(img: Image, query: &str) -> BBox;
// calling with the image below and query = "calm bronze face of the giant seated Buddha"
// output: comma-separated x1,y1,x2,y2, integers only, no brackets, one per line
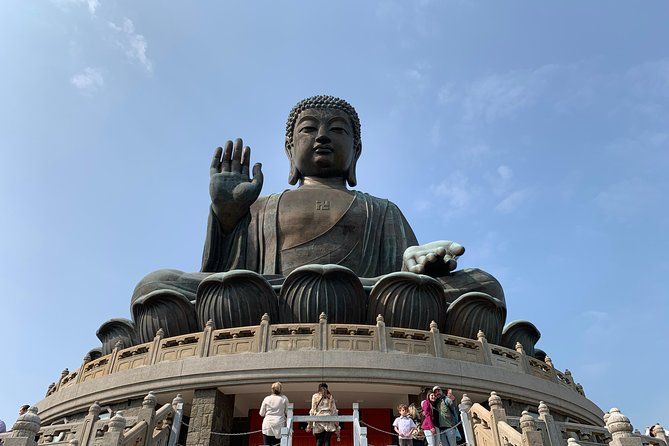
291,109,356,178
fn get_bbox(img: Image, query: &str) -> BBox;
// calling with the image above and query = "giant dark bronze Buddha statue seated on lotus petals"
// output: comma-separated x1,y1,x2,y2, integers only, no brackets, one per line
107,96,506,354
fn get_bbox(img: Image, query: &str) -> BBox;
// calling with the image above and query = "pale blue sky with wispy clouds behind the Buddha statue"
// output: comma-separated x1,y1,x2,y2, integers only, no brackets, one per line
0,0,669,430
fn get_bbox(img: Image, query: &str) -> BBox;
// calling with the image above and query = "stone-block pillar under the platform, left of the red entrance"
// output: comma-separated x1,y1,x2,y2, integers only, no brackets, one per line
186,389,235,446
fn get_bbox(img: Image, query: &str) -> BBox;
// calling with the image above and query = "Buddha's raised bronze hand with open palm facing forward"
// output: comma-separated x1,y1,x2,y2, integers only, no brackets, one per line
209,139,263,233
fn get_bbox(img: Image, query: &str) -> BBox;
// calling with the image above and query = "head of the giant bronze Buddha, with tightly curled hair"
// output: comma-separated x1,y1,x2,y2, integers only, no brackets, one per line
286,96,362,187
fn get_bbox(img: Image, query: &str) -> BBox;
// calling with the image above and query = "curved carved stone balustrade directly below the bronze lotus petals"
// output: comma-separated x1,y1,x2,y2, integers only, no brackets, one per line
47,314,583,396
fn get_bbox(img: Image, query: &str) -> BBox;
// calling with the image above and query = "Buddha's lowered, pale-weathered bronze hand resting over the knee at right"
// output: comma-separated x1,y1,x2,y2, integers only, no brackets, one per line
402,240,465,277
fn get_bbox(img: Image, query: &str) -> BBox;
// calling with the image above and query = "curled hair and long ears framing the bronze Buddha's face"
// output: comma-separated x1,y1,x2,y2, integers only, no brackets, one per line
286,95,362,187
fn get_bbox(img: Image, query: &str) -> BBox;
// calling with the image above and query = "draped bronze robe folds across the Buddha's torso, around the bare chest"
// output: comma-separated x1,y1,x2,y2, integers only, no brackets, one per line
201,191,418,277
